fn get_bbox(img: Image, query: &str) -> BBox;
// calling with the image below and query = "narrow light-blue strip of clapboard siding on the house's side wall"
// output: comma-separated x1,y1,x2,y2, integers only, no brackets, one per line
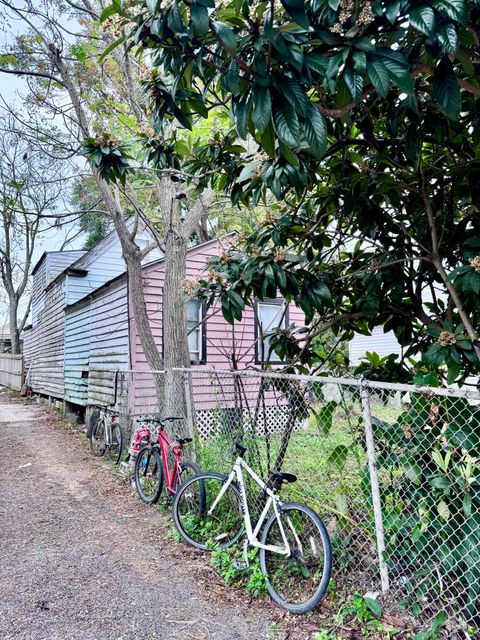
65,300,90,405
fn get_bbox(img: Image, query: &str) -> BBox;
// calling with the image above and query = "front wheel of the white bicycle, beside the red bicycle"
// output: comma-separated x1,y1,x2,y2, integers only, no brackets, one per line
173,473,244,551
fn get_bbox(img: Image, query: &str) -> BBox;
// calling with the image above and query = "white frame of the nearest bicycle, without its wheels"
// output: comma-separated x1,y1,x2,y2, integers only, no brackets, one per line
208,456,302,557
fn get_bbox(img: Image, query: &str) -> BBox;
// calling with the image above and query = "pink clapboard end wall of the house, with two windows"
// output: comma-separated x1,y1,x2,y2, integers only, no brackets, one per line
129,240,305,428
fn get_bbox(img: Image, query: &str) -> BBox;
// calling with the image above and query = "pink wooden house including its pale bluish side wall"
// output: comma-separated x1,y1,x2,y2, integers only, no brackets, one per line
64,234,304,430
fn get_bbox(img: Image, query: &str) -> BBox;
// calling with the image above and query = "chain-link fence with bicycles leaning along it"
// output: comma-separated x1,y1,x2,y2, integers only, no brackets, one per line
109,369,480,637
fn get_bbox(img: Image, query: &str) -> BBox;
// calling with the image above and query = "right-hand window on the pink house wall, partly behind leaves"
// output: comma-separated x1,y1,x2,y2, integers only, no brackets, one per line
255,298,288,364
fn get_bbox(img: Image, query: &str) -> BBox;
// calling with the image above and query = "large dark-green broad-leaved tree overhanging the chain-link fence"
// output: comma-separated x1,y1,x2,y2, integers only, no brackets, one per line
93,0,480,382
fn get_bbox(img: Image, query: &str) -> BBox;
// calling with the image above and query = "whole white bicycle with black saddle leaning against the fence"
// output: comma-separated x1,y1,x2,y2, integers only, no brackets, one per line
173,443,332,613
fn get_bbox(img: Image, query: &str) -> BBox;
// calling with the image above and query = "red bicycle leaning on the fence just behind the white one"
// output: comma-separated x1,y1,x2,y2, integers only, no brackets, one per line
130,417,201,504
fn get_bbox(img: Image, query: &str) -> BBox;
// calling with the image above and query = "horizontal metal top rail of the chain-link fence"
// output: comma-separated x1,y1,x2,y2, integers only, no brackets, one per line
169,368,480,400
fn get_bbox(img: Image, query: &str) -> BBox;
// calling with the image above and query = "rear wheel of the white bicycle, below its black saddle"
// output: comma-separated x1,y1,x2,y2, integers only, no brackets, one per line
259,502,332,614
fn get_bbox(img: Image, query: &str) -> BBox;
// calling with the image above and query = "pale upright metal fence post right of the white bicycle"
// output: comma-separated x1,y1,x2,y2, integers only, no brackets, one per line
360,378,390,593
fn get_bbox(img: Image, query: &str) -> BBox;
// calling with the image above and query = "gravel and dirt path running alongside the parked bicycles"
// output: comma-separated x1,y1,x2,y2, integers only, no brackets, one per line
0,393,271,640
